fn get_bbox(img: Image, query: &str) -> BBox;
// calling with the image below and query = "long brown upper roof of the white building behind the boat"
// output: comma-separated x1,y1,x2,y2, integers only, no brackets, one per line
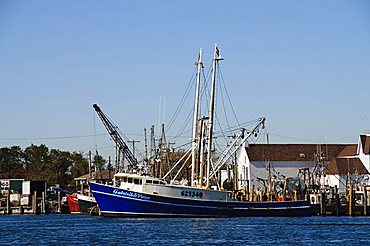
246,144,357,161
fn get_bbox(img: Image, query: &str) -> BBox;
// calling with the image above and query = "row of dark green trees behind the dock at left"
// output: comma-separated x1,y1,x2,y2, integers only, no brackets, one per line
0,144,107,188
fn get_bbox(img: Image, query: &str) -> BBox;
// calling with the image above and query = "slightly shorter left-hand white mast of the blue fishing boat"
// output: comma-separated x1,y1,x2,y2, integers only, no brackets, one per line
191,49,203,186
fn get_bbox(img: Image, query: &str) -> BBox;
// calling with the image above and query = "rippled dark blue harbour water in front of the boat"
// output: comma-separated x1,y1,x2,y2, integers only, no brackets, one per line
0,214,370,245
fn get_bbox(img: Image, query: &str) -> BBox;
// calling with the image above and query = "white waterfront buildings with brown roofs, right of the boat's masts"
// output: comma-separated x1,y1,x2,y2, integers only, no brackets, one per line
237,139,370,193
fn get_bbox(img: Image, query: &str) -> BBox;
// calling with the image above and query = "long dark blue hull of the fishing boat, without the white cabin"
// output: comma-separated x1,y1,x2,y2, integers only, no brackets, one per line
90,183,311,217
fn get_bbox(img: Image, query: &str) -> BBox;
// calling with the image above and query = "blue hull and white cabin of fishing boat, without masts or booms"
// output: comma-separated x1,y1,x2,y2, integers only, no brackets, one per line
90,173,311,217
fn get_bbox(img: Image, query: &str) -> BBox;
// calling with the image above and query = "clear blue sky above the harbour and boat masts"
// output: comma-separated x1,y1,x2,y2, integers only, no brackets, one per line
0,0,370,159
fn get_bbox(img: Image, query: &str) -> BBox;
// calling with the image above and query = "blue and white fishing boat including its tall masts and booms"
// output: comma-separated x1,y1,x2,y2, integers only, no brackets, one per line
90,46,311,217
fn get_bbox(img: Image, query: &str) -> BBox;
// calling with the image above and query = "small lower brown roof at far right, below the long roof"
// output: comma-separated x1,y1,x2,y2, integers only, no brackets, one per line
324,157,369,175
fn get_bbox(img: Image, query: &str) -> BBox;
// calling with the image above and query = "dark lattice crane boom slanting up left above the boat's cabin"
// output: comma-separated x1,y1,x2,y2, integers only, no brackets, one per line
93,104,138,168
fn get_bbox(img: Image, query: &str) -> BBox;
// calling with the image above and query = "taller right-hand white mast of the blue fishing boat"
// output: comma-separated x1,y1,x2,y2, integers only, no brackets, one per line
207,44,223,188
